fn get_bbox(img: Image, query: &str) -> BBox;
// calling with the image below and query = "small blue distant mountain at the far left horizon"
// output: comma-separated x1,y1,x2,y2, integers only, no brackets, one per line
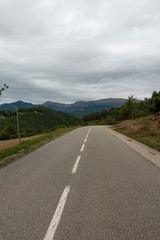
0,101,34,110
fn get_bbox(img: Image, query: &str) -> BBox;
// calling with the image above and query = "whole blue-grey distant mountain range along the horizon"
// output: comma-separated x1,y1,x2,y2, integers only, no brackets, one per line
0,98,126,117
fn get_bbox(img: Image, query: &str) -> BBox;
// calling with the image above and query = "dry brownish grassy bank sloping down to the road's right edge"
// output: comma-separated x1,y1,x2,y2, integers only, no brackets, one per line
114,113,160,152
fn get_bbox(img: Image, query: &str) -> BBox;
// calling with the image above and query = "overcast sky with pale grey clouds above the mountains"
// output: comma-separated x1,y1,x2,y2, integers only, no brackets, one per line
0,0,160,104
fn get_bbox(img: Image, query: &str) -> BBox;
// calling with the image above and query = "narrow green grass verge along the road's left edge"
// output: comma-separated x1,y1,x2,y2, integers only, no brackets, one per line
0,127,77,168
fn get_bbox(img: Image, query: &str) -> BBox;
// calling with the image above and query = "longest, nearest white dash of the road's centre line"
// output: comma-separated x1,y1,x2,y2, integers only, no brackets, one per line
44,185,70,240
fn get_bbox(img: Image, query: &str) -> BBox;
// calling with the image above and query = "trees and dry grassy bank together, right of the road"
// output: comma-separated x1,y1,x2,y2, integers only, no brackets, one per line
83,91,160,151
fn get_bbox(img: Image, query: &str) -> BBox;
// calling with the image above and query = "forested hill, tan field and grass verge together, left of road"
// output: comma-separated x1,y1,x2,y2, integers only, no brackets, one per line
0,106,80,167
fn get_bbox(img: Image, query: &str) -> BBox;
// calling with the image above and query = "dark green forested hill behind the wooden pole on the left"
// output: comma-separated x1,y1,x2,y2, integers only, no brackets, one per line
0,106,79,139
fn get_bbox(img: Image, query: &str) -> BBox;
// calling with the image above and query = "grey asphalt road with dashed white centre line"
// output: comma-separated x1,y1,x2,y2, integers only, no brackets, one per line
0,127,160,240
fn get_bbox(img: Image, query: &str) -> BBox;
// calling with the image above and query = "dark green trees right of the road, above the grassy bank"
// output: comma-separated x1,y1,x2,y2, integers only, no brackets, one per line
82,91,160,125
